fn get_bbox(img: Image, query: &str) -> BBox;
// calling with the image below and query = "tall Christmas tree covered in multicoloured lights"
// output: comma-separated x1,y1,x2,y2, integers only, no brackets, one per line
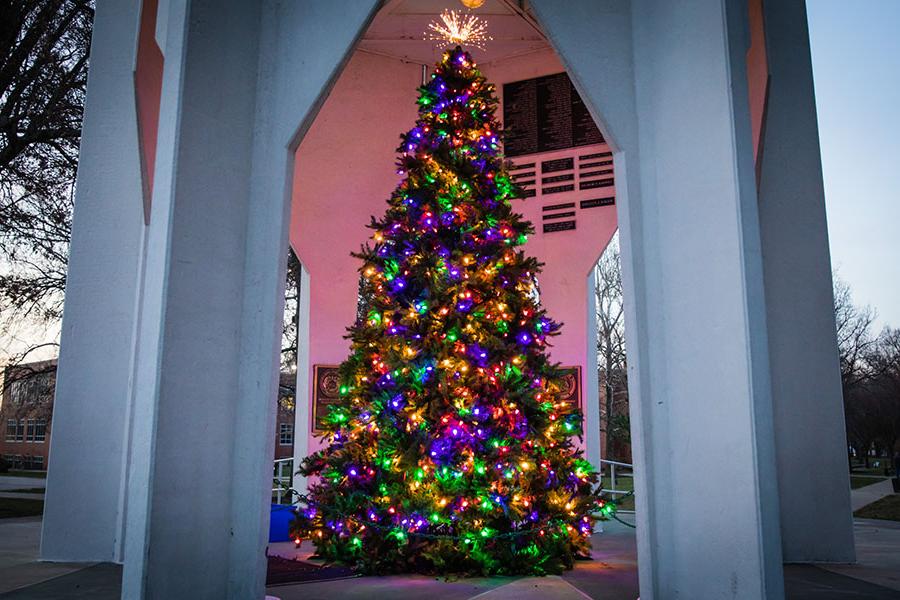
292,46,614,574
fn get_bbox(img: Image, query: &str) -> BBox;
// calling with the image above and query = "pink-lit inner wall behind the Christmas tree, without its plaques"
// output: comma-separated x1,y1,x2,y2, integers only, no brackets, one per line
291,51,616,452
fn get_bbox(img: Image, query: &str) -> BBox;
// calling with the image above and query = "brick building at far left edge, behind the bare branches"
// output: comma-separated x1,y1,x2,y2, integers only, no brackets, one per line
0,360,56,471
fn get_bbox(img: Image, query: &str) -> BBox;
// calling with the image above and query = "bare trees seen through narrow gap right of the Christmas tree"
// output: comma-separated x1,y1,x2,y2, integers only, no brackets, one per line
594,234,631,458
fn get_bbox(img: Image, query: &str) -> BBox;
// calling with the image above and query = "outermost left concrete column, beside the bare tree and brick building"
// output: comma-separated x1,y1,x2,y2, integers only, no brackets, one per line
41,0,144,562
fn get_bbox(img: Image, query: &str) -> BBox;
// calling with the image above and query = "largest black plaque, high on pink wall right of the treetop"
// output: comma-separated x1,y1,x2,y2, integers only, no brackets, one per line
503,73,603,156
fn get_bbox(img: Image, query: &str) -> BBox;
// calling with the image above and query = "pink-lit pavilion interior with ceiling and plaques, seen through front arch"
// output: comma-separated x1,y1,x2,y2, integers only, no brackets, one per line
272,0,636,589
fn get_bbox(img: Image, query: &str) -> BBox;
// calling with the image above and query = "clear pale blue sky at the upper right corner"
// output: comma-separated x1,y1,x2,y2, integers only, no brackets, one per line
806,0,900,328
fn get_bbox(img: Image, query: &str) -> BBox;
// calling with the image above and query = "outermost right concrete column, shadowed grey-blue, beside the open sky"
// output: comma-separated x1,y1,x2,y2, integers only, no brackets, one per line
759,0,855,562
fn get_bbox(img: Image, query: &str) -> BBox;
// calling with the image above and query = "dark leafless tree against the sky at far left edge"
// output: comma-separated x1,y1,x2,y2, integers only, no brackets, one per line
0,0,94,376
